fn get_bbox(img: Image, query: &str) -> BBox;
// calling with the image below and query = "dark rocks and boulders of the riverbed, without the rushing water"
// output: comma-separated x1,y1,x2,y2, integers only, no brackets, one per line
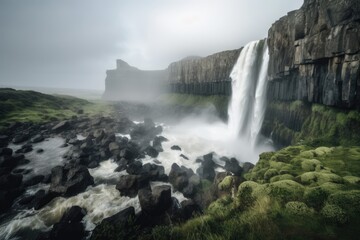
0,112,253,239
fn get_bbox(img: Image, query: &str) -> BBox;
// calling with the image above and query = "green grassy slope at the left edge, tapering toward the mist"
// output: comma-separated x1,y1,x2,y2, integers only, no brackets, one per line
0,88,112,127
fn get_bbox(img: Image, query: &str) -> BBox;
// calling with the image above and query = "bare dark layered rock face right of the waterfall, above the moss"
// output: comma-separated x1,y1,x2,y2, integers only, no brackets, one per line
268,0,360,108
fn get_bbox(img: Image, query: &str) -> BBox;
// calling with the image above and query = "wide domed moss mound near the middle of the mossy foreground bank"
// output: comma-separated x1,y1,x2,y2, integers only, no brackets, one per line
267,180,305,203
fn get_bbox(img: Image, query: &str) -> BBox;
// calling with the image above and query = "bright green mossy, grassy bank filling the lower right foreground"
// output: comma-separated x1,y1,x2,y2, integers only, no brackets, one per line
144,145,360,239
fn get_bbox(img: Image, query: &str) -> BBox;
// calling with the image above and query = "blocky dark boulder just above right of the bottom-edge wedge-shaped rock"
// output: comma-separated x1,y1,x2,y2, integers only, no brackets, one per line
139,185,172,215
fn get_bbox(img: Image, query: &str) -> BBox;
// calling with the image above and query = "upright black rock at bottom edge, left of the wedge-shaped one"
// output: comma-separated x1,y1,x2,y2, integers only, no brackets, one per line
50,206,86,240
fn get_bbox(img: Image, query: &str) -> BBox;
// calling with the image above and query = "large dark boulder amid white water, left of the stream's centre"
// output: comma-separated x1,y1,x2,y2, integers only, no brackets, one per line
49,165,94,196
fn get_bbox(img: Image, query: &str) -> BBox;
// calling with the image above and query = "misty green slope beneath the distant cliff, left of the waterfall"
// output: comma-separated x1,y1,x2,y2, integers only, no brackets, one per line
159,93,230,119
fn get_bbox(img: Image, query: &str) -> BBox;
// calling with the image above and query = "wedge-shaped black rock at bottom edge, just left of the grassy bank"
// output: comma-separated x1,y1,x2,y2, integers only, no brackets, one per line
90,207,139,240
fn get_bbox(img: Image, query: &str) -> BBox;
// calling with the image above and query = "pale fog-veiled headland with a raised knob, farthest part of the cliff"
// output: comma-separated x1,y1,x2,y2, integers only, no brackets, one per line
103,60,168,102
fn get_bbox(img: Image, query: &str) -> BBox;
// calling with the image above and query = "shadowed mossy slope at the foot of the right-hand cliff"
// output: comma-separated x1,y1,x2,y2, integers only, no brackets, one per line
262,101,360,146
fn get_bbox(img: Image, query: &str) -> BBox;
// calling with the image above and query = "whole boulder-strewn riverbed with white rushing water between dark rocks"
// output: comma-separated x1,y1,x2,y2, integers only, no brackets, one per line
0,112,264,239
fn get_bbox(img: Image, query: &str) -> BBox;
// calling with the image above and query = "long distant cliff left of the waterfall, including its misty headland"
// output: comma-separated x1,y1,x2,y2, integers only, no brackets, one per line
103,49,241,101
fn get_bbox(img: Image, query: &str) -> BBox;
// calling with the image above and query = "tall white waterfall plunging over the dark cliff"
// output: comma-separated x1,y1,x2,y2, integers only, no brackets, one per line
228,40,269,146
